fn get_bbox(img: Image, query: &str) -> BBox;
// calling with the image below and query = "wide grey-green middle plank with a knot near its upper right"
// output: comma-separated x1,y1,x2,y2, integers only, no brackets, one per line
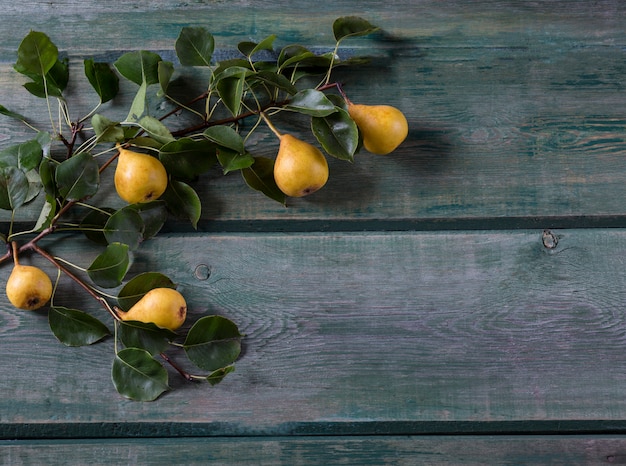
0,229,626,438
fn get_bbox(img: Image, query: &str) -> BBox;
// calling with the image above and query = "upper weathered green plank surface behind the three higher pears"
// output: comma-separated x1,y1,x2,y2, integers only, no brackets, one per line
0,1,626,230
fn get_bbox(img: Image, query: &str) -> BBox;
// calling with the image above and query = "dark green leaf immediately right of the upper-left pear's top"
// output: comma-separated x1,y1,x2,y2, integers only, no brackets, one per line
159,138,217,180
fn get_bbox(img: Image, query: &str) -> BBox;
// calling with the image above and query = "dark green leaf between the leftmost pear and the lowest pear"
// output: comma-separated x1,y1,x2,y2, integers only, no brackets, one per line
48,306,111,346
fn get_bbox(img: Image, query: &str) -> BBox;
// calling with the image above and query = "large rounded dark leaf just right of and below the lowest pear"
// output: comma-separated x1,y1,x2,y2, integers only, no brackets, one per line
183,316,243,371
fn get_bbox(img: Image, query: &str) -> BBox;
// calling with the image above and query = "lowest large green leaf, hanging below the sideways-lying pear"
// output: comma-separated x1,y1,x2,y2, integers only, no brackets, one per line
111,348,170,401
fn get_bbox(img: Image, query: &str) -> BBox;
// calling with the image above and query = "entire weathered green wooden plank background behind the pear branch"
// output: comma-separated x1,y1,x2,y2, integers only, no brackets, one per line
0,0,626,465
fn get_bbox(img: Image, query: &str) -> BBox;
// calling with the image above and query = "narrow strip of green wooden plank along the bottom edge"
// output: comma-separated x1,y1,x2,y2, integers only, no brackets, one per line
0,435,626,466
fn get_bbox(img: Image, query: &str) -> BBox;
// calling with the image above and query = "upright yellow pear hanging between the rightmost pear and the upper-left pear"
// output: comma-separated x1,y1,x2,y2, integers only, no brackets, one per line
274,134,328,197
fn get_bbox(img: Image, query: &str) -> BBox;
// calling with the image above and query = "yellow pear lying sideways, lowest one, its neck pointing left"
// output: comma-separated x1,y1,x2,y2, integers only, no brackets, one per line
116,288,187,330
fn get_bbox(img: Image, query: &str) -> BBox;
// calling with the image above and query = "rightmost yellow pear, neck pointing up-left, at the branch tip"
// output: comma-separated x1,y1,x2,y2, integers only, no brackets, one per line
347,101,409,155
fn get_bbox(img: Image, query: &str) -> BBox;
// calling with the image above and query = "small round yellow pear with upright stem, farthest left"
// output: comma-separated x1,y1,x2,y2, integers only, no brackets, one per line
6,243,52,311
